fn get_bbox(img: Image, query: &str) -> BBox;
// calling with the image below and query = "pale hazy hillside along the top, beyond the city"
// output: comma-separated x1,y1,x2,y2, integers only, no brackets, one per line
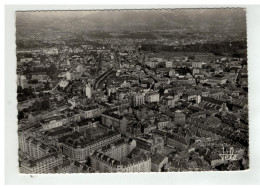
16,9,246,32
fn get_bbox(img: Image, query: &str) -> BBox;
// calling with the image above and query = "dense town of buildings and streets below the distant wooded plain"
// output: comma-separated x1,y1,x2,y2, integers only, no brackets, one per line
17,13,249,174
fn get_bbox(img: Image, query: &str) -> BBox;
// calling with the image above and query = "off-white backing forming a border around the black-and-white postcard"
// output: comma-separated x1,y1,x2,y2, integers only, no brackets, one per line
4,5,260,185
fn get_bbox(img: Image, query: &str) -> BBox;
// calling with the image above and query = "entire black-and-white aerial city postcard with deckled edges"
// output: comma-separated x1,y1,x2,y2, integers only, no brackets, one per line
16,8,249,174
